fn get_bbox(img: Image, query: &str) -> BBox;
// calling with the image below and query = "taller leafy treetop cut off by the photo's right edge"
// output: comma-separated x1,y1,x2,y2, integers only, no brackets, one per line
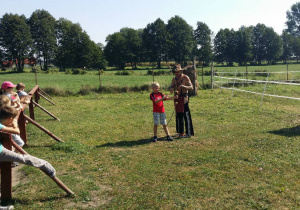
285,2,300,37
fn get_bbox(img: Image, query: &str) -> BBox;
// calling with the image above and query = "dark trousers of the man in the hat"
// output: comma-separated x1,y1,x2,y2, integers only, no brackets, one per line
176,103,194,136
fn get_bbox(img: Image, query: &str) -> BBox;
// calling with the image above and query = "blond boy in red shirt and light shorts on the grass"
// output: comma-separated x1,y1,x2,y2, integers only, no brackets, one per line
150,82,178,142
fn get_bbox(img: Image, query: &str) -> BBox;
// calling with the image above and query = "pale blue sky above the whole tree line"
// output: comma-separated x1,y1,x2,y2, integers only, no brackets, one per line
0,0,298,45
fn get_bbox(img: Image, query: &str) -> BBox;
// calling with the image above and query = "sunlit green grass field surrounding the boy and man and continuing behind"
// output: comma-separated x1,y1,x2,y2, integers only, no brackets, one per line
0,66,300,209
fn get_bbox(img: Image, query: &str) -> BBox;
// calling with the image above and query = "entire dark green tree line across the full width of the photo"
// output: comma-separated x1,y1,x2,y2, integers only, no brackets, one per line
0,3,300,71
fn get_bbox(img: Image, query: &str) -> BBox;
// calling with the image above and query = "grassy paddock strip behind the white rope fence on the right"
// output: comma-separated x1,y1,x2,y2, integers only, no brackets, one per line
213,71,300,100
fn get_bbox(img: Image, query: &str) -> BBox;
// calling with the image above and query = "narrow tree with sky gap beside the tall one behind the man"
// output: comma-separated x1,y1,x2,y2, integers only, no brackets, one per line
194,22,213,65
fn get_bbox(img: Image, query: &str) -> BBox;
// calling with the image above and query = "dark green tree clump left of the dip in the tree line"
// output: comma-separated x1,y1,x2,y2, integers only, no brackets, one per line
0,10,106,72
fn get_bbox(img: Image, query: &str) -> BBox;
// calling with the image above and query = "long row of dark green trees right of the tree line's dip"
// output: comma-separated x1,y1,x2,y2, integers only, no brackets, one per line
104,3,300,69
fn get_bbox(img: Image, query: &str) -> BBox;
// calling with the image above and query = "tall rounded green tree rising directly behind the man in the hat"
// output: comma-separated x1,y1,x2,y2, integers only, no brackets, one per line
166,16,195,65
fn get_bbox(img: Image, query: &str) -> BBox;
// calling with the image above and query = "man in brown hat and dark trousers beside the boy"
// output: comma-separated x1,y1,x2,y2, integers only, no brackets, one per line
169,64,194,138
